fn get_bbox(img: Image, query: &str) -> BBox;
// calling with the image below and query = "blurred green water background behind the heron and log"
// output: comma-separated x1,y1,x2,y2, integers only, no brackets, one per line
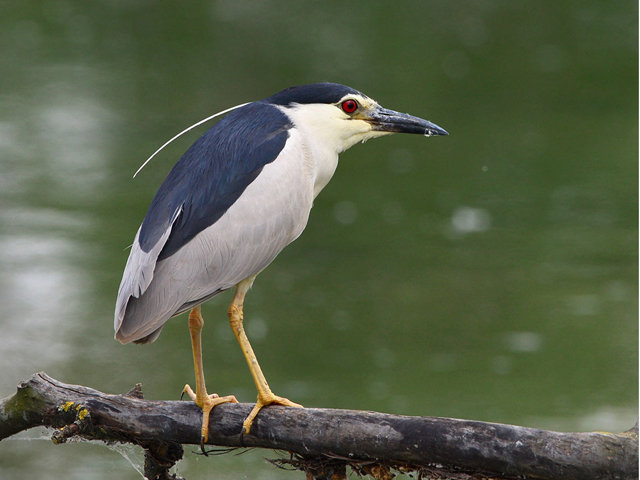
0,0,638,480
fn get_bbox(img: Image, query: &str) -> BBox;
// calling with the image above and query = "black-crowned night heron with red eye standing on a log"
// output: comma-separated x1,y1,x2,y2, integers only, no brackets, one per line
114,82,448,451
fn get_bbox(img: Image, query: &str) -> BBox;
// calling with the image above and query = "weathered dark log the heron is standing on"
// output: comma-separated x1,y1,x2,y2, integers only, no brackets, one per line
0,373,638,480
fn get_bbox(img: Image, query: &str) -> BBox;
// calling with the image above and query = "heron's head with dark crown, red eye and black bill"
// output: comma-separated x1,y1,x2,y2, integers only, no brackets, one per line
265,83,448,153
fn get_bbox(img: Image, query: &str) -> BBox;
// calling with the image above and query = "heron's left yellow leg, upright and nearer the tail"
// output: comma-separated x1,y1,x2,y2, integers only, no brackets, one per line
183,306,238,445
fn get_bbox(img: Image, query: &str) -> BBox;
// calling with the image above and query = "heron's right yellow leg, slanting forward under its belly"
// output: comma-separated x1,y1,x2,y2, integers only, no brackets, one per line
229,277,302,434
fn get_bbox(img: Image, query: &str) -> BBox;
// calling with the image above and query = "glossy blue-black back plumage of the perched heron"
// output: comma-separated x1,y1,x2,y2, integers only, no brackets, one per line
139,101,293,260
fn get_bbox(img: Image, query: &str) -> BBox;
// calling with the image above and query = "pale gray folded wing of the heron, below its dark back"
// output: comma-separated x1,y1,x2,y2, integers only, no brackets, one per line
114,136,314,343
